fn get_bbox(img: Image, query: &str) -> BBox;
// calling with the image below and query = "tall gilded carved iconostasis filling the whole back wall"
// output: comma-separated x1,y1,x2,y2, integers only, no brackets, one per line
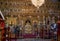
0,0,60,38
